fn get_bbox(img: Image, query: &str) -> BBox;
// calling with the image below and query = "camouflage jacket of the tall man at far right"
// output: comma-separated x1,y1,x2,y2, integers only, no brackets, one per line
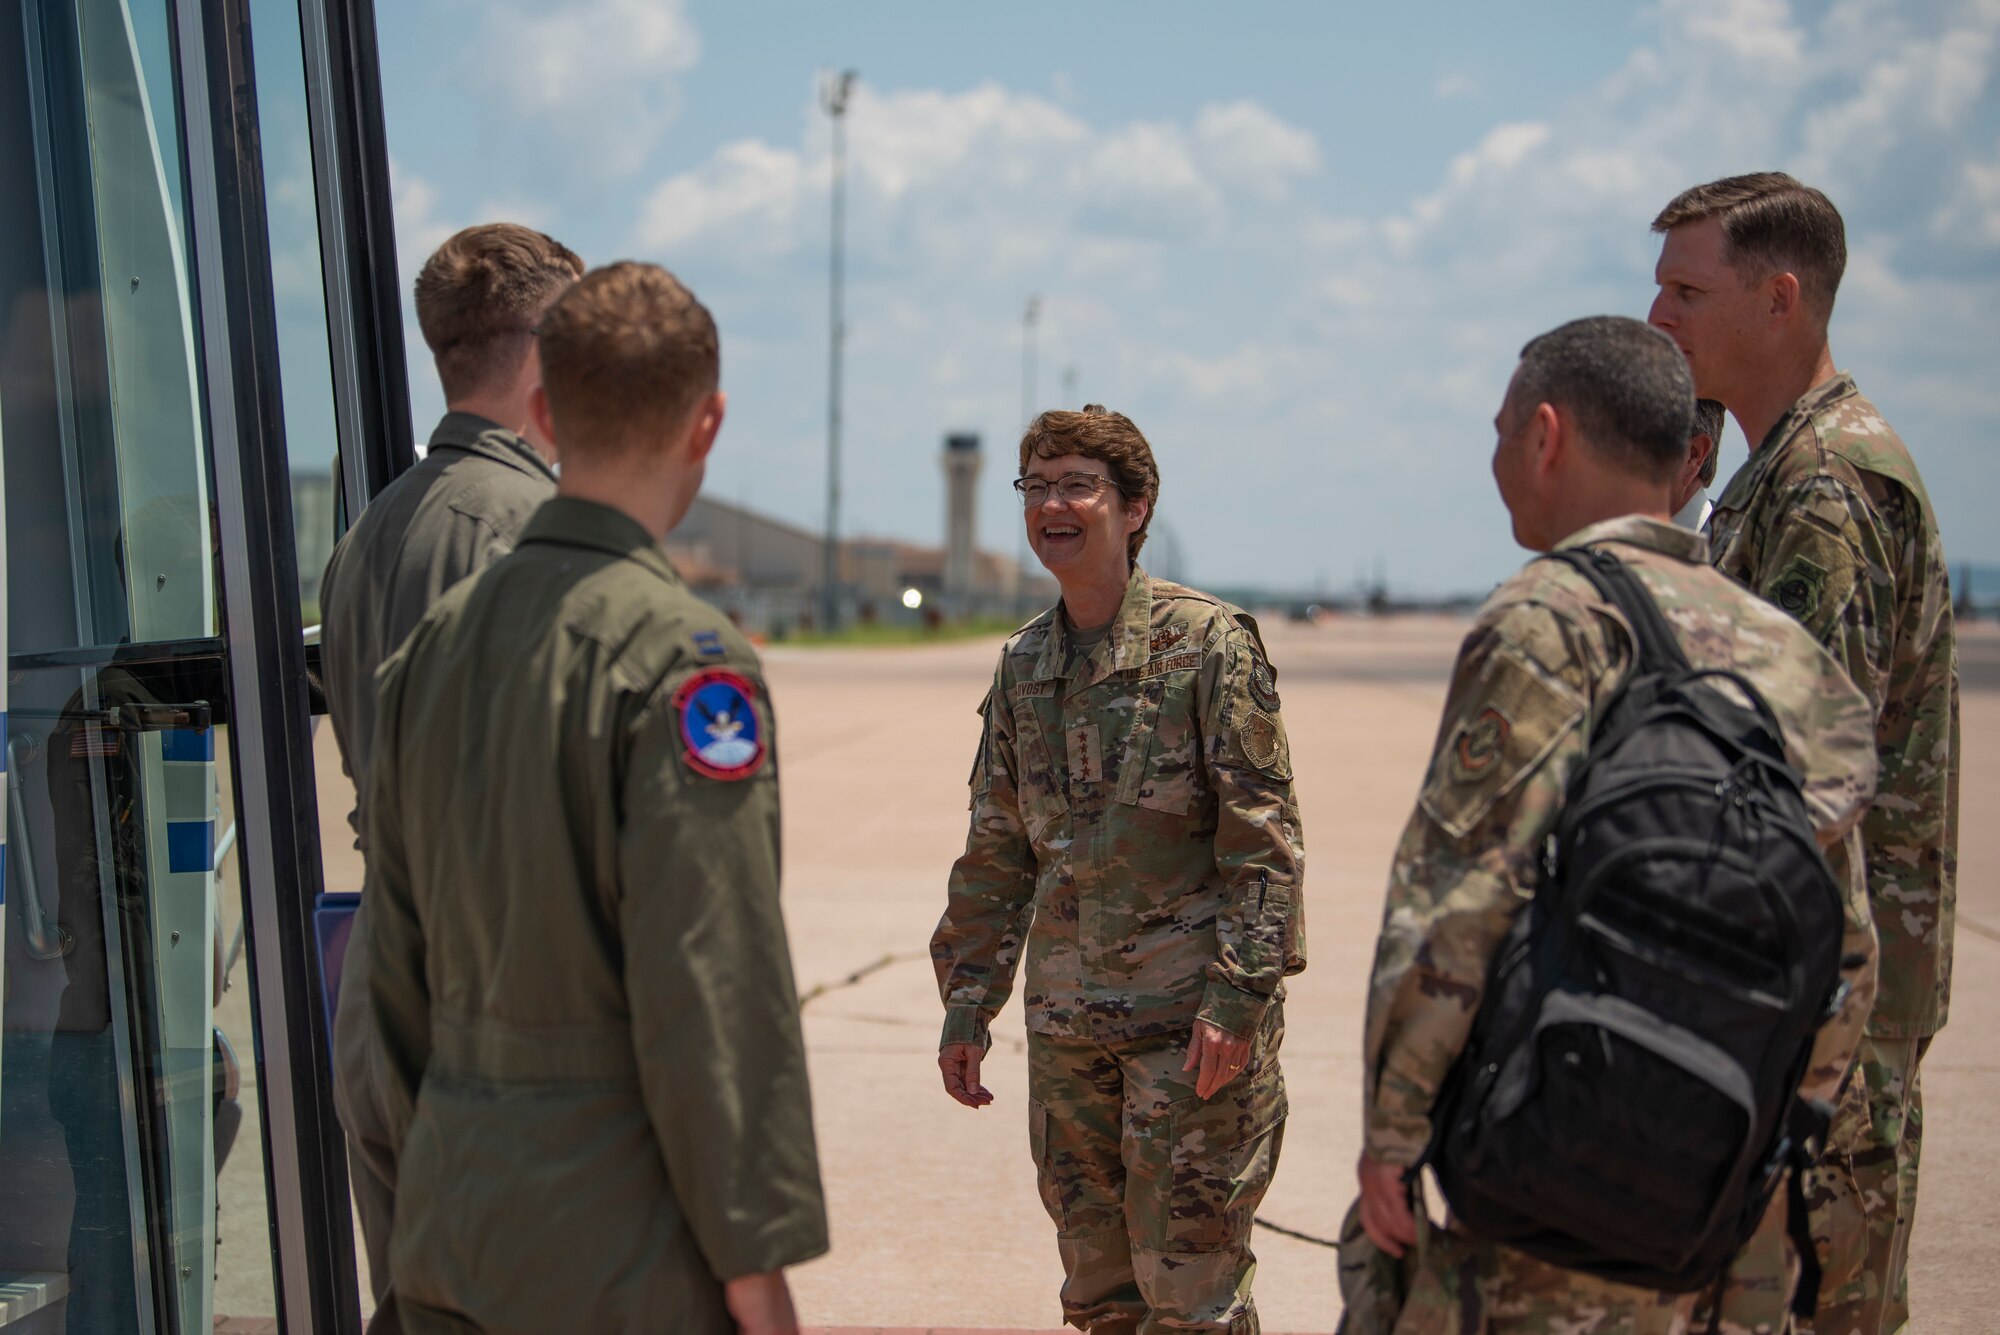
1708,374,1960,1037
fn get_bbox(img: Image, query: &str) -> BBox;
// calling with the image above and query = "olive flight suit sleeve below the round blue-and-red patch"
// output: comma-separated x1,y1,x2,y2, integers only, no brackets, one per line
618,662,826,1281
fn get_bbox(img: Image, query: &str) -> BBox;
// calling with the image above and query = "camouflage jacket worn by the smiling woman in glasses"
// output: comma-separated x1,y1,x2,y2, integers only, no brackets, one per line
930,568,1306,1043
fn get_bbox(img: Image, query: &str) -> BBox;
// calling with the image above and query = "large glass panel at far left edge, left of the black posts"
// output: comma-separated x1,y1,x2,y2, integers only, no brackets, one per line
0,0,274,1331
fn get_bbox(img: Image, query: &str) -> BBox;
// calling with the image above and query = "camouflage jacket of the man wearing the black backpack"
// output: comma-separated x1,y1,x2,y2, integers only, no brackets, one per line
1362,516,1874,1163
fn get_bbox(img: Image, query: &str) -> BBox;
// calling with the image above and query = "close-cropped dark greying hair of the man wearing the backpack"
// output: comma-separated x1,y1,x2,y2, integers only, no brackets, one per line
1508,316,1694,482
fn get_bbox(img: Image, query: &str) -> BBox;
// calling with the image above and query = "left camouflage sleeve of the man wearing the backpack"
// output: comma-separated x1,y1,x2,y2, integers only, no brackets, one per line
1362,602,1596,1163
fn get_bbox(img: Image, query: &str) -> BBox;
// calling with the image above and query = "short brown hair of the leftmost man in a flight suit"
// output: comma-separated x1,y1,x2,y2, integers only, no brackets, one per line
416,222,584,400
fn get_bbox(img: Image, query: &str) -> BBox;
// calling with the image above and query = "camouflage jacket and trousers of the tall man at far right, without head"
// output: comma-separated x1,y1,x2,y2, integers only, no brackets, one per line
1710,367,1960,1335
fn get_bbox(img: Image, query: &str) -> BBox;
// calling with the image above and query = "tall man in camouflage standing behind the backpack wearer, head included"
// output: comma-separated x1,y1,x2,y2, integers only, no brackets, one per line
1654,172,1960,1335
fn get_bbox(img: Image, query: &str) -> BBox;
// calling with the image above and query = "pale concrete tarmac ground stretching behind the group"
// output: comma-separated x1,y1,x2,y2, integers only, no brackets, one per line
218,618,2000,1335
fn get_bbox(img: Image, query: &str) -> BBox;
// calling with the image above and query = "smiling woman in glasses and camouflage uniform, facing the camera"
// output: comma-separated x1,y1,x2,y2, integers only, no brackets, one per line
930,406,1306,1331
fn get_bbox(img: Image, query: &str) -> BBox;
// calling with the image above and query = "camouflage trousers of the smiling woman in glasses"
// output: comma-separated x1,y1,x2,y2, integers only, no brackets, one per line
1028,1005,1286,1335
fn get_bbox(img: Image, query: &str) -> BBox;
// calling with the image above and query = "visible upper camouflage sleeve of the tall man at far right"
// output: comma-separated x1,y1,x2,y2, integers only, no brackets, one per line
1752,474,1896,713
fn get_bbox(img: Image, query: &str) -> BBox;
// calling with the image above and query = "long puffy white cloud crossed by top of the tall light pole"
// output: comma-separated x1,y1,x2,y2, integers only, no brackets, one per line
634,84,1320,272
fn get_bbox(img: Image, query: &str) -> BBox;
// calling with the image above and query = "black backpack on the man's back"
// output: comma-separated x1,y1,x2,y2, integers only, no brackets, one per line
1426,550,1844,1313
